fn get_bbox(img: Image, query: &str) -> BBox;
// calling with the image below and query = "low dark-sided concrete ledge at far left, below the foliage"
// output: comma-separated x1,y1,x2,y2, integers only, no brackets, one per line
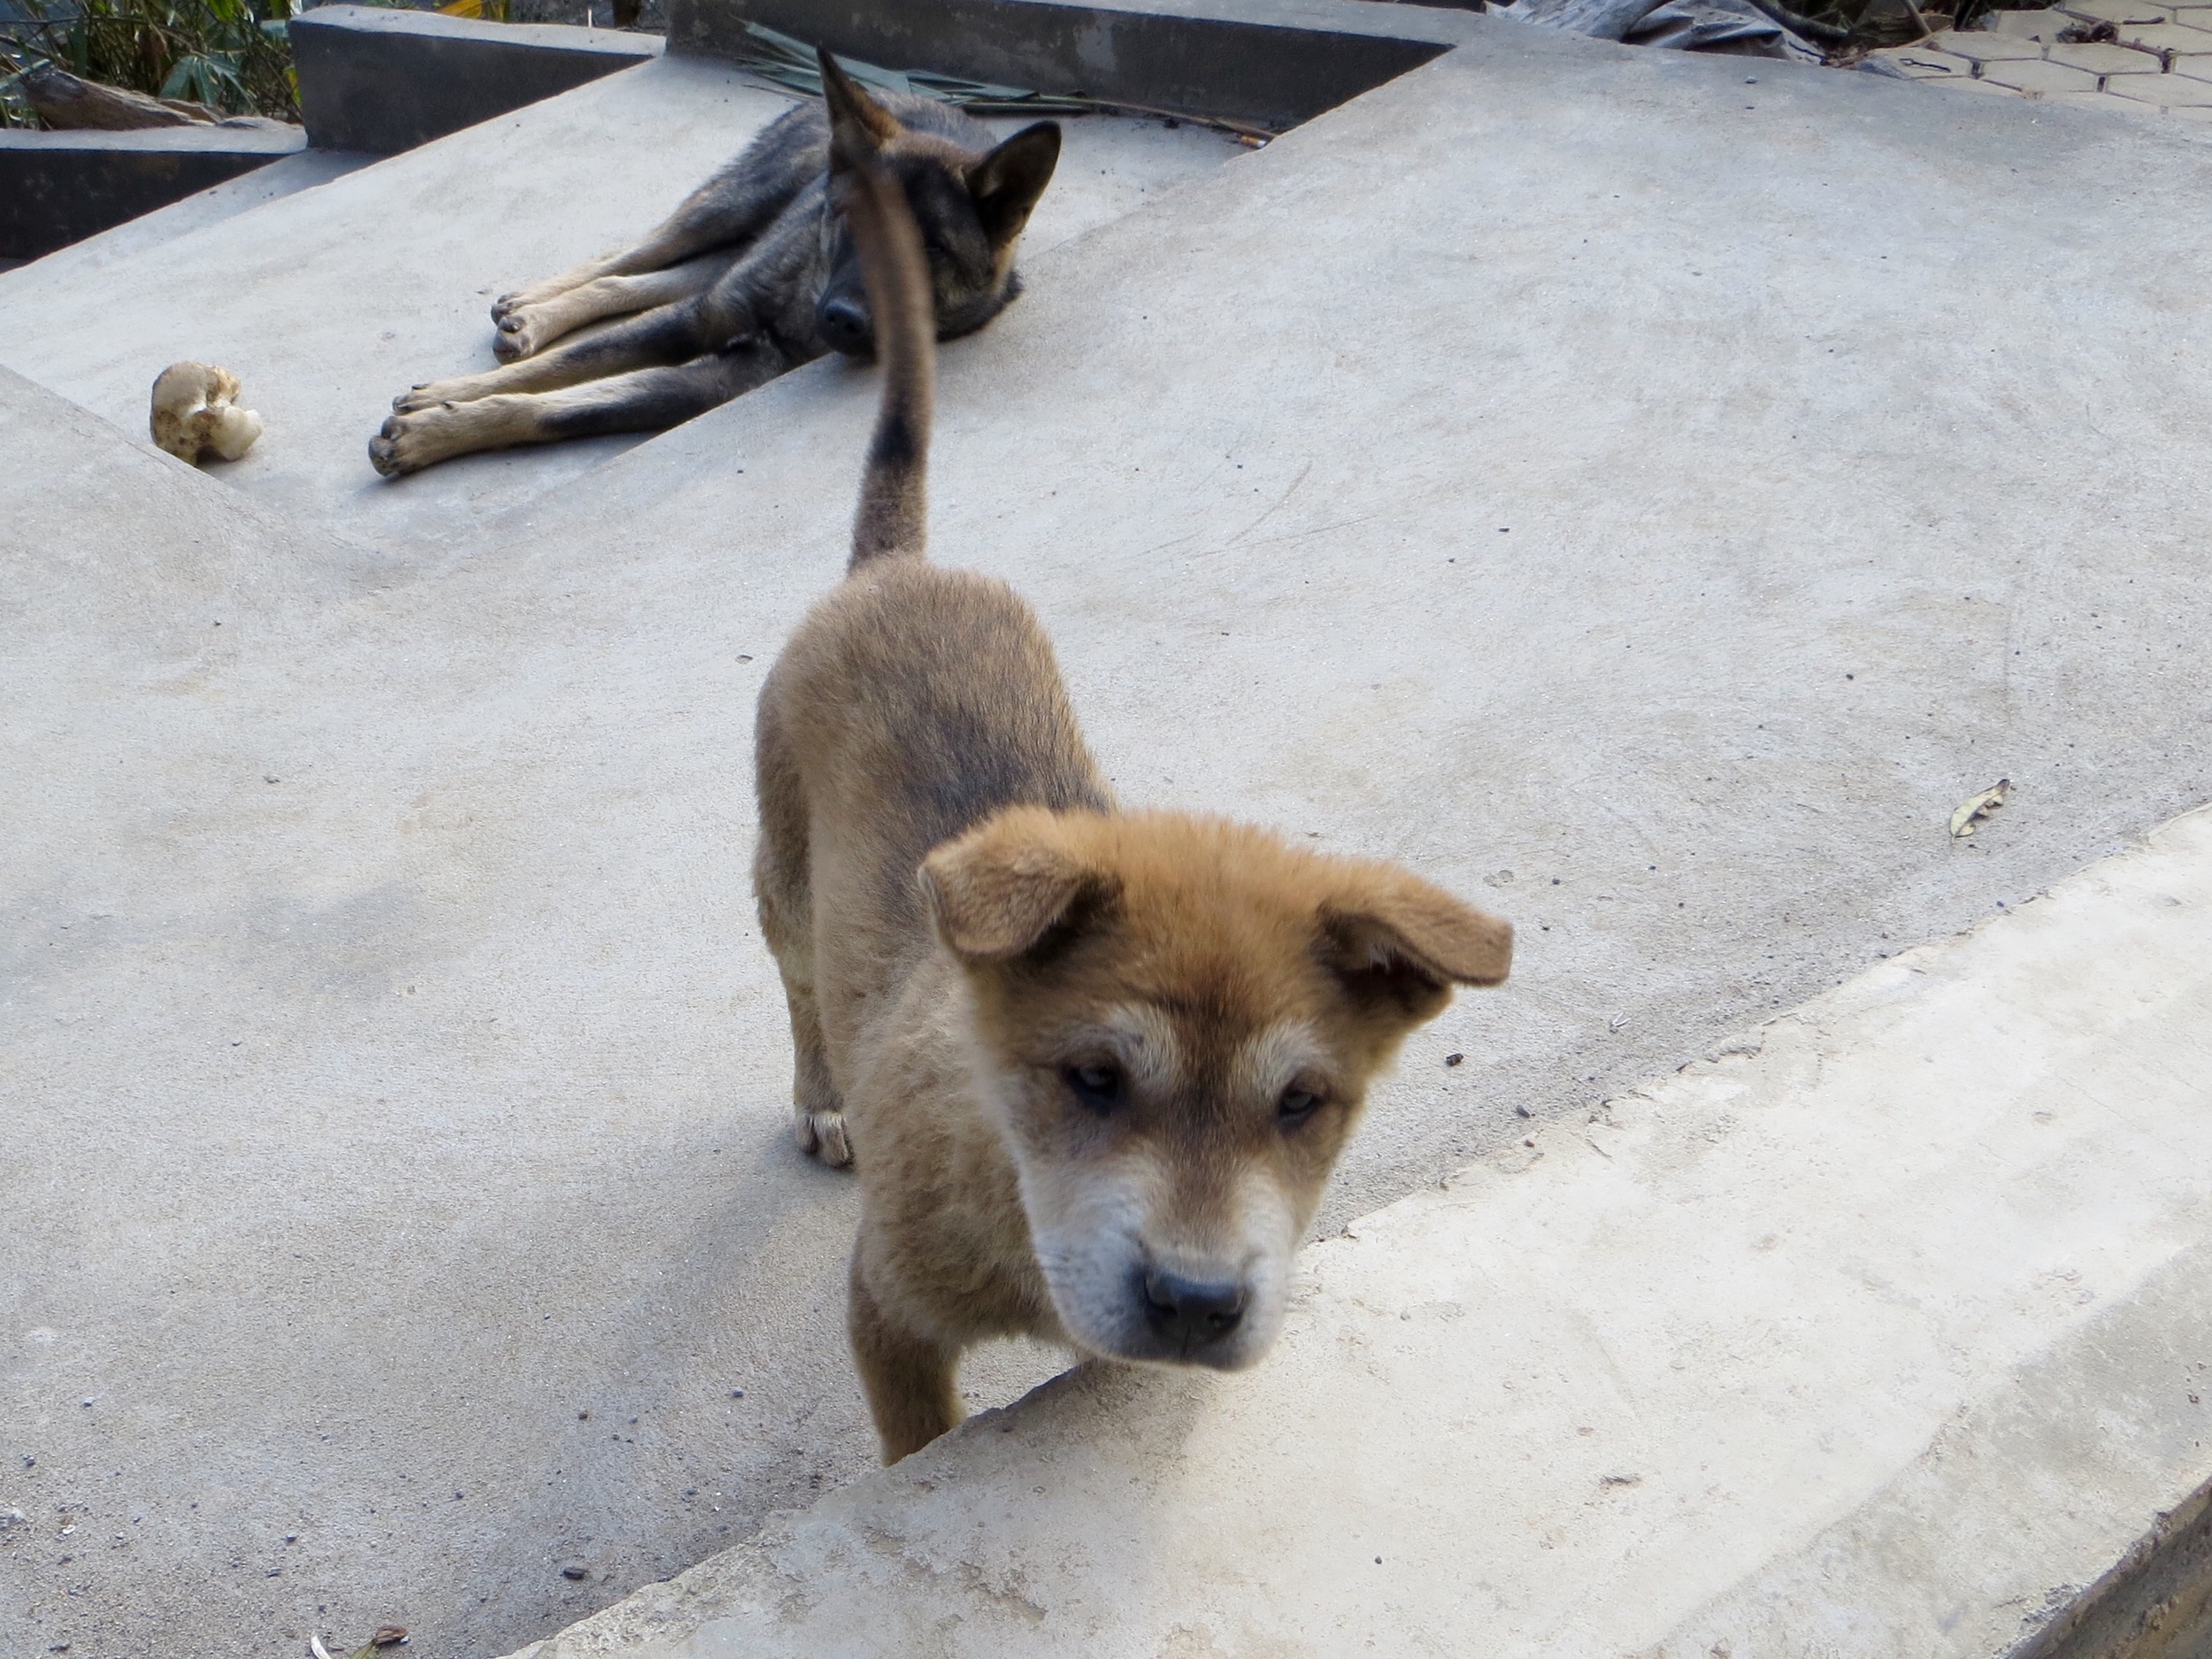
0,127,308,259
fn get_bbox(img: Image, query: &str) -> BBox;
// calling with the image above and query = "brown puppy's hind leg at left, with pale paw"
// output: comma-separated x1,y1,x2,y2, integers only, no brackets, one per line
752,684,852,1168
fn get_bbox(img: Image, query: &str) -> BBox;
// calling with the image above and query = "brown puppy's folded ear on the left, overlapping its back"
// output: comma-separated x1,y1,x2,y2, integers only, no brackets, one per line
916,812,1113,963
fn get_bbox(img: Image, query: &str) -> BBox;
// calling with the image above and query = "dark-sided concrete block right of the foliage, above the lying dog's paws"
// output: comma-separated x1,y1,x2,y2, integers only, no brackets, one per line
292,7,662,155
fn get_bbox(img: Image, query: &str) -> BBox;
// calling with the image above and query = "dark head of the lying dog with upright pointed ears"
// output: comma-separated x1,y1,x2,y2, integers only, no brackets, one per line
814,53,1060,357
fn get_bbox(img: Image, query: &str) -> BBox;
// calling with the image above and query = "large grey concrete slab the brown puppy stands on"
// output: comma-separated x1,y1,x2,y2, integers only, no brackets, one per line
12,20,2212,1659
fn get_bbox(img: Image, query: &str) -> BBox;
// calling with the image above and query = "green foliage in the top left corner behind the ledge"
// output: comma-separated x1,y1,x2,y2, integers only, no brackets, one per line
0,0,299,127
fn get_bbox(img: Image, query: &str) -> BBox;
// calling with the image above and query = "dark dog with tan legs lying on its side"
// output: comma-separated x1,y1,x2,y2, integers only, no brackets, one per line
370,60,1060,478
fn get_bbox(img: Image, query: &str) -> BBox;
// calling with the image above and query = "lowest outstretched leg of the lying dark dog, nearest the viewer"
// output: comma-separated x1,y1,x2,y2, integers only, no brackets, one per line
370,343,790,478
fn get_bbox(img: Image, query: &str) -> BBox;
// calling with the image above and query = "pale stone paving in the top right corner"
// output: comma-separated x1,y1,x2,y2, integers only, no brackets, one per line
1870,0,2212,122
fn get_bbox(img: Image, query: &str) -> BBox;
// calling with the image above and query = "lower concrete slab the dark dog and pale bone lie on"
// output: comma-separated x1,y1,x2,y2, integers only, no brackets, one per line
0,57,1241,547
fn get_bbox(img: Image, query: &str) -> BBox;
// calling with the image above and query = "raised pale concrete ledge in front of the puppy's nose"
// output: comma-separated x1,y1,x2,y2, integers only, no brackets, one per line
497,812,2212,1659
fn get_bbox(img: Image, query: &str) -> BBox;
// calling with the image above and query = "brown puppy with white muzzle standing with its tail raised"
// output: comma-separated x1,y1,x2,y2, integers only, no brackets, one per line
755,157,1513,1463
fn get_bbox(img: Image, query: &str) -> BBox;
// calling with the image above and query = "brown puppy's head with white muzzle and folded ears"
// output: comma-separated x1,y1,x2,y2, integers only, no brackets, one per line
920,808,1513,1370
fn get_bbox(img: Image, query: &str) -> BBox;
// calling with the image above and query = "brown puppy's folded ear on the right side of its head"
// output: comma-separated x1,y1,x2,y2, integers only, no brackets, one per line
1321,865,1513,1022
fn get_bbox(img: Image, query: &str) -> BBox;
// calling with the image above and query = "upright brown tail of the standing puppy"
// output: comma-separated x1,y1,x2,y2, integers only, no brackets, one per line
845,136,938,575
